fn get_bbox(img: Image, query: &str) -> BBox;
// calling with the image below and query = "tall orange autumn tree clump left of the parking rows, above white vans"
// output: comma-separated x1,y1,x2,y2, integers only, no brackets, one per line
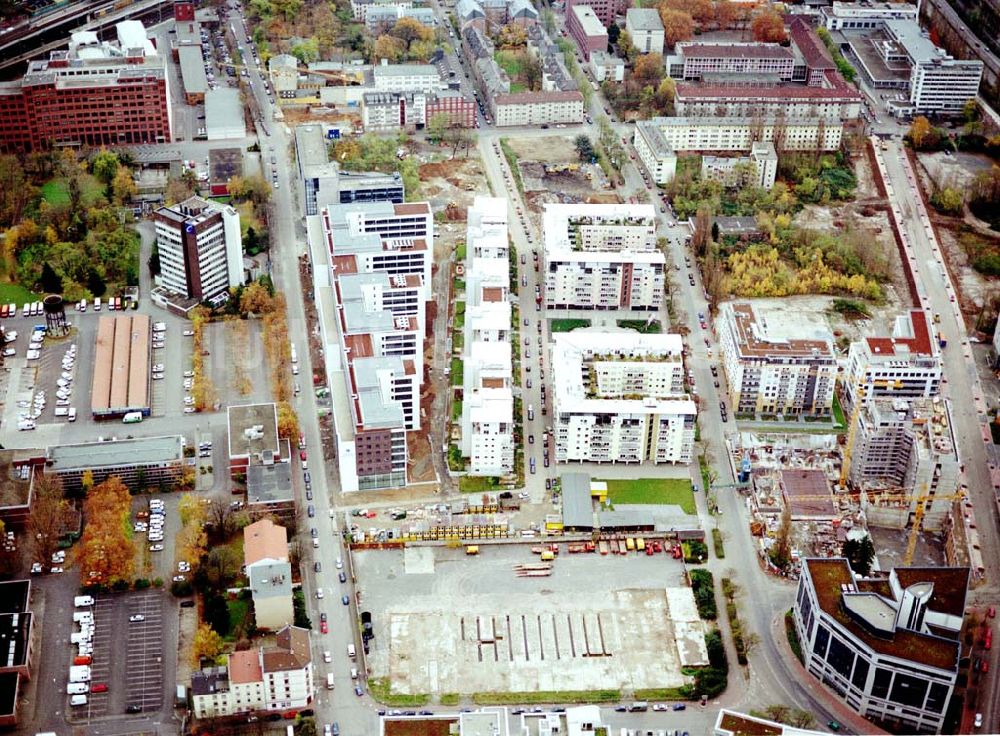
77,476,135,585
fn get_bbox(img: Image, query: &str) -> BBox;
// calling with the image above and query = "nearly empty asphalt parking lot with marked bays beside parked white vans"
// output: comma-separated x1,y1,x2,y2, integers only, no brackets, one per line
67,590,166,721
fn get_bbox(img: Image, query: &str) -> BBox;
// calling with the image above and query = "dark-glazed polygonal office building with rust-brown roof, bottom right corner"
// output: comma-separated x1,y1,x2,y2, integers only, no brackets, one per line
792,558,969,733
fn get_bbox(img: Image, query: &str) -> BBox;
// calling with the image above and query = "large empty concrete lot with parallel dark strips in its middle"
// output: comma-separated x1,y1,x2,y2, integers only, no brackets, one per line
355,544,706,693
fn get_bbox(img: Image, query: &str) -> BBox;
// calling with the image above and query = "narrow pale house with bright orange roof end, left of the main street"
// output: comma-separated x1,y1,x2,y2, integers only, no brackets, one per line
243,518,294,630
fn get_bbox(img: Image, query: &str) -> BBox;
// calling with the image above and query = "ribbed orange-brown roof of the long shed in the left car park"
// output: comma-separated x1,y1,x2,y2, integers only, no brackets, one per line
91,314,151,416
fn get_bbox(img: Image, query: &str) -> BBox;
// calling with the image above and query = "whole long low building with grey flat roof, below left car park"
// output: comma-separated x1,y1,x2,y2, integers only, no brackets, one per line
45,435,185,493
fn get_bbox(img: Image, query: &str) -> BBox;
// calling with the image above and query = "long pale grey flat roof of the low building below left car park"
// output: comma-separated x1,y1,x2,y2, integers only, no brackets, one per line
46,434,184,473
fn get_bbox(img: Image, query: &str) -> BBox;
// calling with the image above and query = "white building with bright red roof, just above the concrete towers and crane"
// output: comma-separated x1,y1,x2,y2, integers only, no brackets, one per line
844,309,942,409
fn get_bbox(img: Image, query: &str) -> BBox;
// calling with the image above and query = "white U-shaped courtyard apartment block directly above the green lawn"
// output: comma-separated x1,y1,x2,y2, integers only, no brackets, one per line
551,332,697,464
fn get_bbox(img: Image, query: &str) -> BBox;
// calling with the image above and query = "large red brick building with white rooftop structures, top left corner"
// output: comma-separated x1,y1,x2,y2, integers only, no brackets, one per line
0,25,171,153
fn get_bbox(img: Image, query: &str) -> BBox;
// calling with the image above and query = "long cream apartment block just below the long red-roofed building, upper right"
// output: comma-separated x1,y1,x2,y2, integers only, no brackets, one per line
635,117,844,154
